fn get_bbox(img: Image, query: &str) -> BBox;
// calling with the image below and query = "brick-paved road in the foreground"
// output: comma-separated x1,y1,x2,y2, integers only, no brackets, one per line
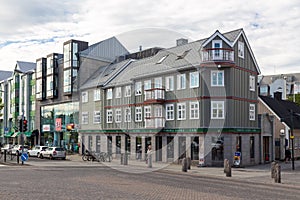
0,160,300,200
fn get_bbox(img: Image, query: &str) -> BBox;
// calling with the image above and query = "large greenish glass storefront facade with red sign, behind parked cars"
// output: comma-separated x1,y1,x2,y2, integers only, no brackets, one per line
40,102,79,152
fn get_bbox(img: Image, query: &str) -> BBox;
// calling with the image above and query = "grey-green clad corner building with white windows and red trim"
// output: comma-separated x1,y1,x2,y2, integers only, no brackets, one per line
79,29,260,165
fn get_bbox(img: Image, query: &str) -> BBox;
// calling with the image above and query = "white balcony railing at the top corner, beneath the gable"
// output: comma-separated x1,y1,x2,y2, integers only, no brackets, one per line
202,48,234,62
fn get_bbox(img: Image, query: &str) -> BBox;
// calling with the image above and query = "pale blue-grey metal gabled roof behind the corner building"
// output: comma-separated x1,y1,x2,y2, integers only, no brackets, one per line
80,37,129,62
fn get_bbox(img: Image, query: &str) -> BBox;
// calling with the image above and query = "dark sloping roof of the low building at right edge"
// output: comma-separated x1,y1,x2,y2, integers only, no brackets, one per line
259,96,300,129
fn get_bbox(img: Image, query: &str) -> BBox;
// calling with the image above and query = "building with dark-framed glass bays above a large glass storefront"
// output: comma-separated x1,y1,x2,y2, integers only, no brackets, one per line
36,38,127,151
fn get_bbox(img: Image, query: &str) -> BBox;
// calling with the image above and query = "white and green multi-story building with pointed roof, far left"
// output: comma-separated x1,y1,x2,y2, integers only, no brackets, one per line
1,61,36,145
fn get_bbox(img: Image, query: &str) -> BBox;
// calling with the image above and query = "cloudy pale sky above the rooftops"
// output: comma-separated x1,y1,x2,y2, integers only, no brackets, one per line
0,0,300,75
